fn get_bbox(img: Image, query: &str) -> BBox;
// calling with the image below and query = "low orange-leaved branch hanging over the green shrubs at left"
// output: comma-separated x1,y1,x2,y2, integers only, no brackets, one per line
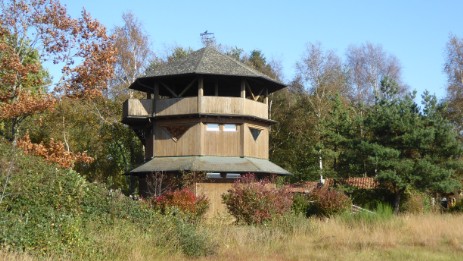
17,134,94,168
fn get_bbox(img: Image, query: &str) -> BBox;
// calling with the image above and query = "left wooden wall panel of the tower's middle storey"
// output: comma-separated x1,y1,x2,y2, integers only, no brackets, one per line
154,122,201,157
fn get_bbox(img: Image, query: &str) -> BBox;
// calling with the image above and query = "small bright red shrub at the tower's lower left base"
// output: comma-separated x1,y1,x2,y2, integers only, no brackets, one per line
151,188,209,218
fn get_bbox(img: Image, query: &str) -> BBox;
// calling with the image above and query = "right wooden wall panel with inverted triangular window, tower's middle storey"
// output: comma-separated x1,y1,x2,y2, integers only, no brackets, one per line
243,123,269,159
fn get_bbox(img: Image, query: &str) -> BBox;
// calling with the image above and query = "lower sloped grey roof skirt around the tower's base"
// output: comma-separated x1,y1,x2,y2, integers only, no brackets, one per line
131,156,291,175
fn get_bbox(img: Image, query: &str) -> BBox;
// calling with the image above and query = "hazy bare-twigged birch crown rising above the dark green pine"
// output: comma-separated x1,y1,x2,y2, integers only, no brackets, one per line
346,43,407,105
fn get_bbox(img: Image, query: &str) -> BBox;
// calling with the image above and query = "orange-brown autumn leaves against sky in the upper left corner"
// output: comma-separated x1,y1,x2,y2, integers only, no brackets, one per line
0,0,116,98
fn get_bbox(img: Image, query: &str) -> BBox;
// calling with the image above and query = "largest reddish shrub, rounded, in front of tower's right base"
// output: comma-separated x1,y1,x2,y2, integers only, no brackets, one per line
222,174,292,224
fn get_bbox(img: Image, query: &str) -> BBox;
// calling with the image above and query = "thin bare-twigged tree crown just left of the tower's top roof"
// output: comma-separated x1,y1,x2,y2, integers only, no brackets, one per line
110,12,154,98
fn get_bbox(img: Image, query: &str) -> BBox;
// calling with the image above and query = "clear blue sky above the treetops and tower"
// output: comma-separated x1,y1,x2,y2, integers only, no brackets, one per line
61,0,463,98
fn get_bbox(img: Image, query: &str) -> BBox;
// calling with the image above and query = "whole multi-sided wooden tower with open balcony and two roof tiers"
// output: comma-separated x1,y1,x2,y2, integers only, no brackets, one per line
123,47,289,211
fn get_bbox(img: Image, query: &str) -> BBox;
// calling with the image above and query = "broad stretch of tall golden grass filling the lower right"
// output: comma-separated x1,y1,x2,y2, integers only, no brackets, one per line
201,212,463,260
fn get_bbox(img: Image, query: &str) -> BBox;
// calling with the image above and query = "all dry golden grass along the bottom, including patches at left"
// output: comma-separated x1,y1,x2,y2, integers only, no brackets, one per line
0,214,463,261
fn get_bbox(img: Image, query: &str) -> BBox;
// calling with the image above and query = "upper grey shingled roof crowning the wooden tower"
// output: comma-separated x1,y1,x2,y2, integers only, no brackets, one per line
130,47,285,92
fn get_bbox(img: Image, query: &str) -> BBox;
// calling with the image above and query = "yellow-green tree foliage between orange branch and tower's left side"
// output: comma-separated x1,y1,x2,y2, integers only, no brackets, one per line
23,98,143,190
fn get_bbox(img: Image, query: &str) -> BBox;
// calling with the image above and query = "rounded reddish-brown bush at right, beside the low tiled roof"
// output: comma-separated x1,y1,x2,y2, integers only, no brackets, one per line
307,187,352,217
